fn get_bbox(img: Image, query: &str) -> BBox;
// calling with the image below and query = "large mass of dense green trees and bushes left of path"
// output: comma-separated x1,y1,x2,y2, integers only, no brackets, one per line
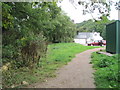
2,2,76,87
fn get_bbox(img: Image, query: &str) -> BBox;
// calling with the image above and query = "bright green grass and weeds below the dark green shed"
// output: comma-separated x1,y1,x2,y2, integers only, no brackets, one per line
92,53,120,88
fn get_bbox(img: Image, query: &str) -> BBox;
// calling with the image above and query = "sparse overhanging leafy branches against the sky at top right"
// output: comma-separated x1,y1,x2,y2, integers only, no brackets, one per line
69,0,120,21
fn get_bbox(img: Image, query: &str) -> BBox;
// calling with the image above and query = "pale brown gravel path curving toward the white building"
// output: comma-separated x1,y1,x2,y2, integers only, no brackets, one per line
29,48,103,88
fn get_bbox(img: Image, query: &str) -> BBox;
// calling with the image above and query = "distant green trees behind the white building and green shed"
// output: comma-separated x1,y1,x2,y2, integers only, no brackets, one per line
77,16,114,39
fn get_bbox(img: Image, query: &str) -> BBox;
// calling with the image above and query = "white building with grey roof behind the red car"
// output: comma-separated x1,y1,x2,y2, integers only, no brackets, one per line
74,32,103,45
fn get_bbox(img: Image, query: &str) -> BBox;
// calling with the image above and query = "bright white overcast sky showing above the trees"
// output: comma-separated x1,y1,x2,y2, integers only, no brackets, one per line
58,0,118,23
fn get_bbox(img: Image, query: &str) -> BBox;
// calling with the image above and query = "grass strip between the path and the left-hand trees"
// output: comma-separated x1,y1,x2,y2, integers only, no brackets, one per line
3,43,97,87
